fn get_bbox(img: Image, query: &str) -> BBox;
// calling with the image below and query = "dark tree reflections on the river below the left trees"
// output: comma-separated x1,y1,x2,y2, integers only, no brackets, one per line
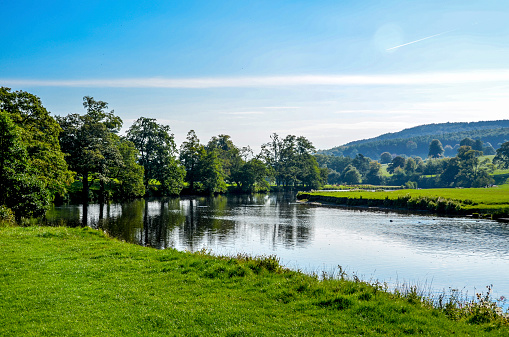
46,194,312,251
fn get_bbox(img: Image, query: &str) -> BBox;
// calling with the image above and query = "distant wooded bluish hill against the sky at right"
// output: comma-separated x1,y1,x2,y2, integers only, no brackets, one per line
318,120,509,160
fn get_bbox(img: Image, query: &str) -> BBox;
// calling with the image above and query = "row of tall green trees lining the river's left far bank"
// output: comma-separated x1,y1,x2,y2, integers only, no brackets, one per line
0,87,327,220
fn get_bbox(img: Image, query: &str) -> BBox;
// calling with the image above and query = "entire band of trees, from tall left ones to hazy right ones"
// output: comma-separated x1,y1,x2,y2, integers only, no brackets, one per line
0,87,509,221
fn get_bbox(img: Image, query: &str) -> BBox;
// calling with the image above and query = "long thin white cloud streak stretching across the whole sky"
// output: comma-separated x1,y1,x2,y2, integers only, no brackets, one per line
0,69,509,89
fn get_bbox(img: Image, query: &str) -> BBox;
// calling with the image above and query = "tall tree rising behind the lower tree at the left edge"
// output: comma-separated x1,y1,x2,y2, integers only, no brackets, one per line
0,87,72,195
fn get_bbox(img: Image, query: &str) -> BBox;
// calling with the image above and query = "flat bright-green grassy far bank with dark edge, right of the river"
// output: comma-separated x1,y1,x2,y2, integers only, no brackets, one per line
297,185,509,219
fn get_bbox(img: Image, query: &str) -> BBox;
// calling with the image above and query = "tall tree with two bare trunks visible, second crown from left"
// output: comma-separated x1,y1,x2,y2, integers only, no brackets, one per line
57,96,122,204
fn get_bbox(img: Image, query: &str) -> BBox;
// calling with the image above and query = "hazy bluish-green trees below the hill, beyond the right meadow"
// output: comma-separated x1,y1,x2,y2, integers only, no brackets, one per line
316,137,509,188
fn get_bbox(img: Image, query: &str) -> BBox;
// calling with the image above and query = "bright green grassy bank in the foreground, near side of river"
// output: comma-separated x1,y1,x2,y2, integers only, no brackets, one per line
0,227,509,336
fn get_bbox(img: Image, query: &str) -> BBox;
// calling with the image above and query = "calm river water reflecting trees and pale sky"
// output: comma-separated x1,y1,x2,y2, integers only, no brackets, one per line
47,194,509,306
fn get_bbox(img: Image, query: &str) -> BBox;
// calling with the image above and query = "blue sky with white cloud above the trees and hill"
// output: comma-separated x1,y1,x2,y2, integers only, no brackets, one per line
0,0,509,149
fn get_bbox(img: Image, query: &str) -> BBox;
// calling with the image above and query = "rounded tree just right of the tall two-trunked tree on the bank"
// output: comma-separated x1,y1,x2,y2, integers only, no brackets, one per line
127,117,185,195
